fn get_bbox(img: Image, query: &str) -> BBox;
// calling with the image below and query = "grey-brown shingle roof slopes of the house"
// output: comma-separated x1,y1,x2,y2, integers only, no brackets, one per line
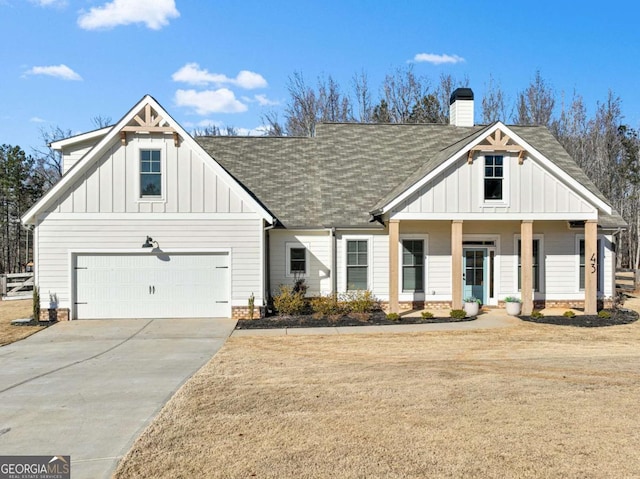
195,123,624,228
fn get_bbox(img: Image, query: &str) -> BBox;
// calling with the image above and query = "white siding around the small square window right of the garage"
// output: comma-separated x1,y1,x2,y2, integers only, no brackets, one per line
269,230,333,296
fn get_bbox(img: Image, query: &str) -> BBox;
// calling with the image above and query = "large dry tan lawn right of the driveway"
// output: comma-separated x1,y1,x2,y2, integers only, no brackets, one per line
115,304,640,478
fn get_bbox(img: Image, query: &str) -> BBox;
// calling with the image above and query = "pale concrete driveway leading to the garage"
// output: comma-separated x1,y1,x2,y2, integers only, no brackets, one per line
0,319,236,479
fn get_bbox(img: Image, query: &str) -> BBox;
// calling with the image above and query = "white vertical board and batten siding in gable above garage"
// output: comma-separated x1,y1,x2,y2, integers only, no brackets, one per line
49,135,253,218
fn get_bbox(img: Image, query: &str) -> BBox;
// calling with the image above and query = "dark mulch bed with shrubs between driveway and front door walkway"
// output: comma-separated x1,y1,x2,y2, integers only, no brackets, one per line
236,311,476,329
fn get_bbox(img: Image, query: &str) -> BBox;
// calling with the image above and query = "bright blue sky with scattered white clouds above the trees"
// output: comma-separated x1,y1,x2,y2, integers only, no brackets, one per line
0,0,640,152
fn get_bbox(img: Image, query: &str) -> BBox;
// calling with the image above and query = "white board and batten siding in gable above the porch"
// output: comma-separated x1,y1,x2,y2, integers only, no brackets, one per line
392,155,595,219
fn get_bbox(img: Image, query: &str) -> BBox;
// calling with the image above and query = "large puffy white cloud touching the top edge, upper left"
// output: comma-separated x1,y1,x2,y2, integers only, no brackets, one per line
78,0,180,30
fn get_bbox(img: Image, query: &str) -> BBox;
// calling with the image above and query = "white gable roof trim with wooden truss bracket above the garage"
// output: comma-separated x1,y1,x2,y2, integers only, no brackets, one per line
21,95,274,228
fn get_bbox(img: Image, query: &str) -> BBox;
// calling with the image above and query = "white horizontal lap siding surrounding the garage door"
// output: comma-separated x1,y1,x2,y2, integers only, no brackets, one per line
37,214,263,314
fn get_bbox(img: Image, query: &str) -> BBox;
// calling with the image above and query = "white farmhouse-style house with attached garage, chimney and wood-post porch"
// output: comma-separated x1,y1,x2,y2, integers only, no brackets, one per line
23,88,626,319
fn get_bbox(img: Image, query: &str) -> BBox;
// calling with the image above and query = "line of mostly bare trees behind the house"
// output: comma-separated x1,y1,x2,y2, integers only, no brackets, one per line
0,66,640,274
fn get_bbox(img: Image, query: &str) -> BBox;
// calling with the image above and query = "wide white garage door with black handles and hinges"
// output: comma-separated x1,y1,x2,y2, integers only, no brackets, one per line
75,253,231,319
